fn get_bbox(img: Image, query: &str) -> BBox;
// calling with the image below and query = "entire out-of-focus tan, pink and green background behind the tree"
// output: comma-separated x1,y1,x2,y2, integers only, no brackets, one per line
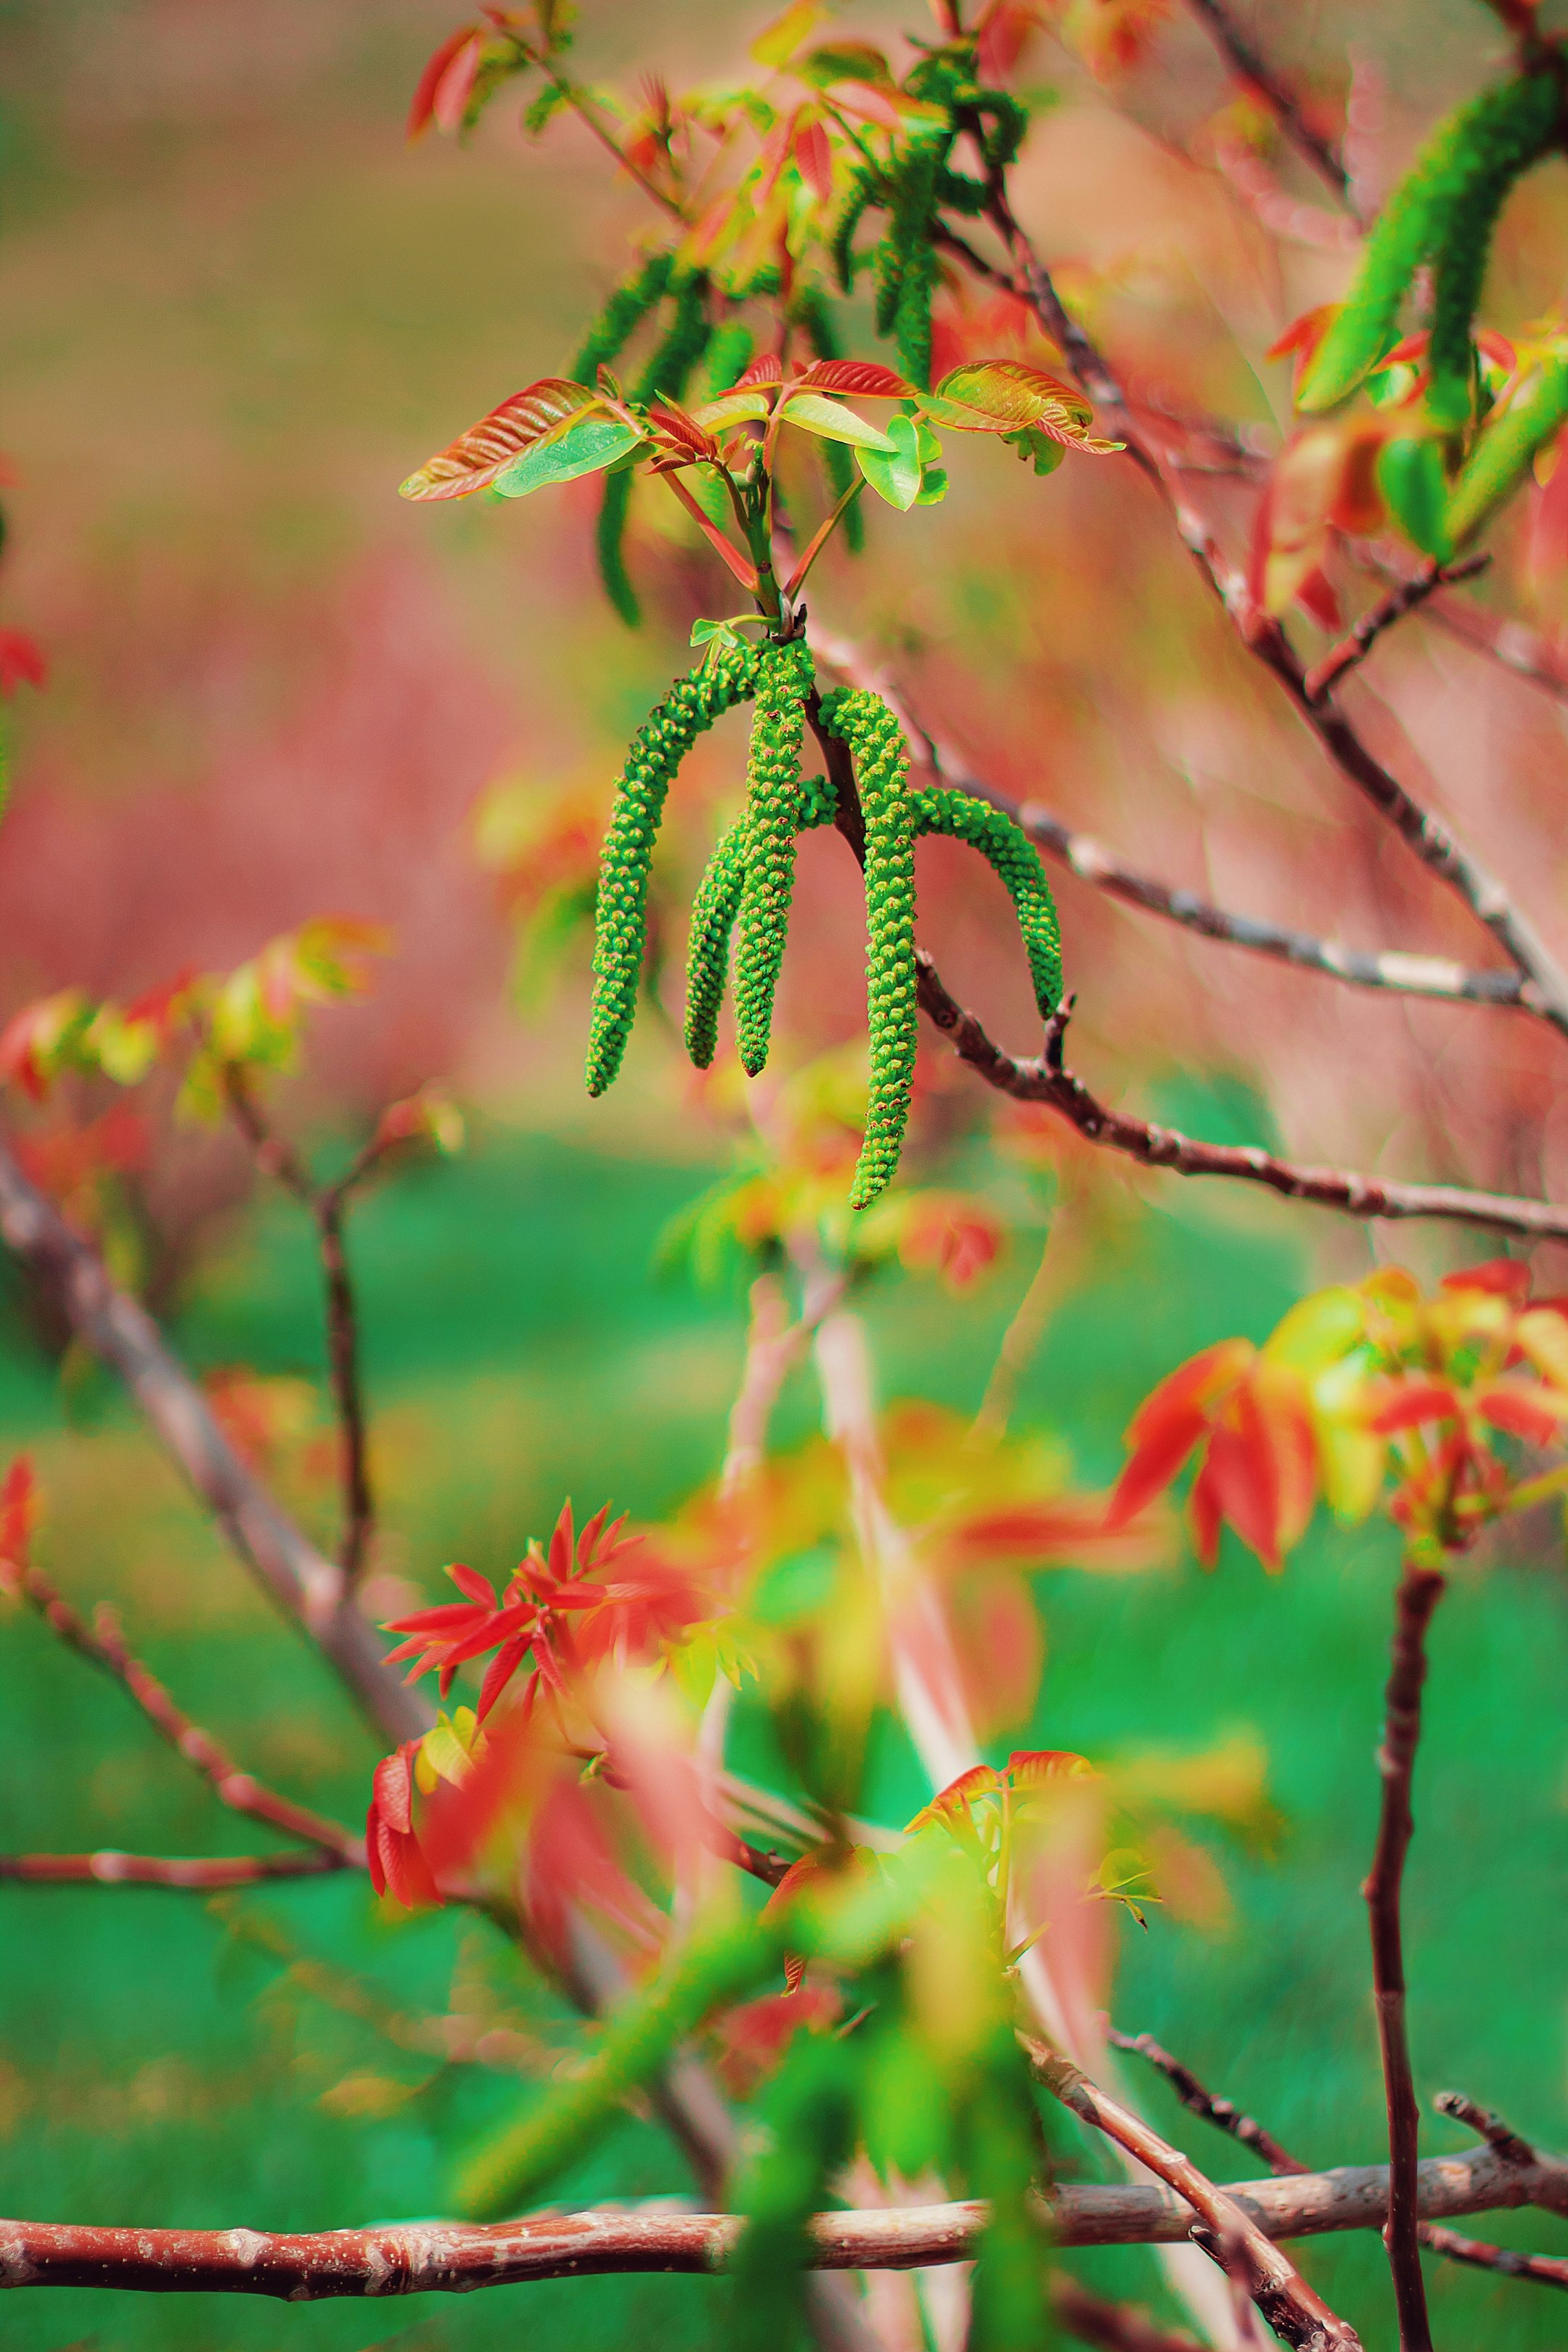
0,0,1568,2352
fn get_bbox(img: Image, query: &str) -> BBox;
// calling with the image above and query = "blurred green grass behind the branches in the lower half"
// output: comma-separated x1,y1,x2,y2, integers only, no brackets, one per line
0,1129,1568,2352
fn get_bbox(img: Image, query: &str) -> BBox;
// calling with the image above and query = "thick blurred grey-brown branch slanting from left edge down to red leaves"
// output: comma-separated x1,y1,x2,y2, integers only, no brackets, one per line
0,1146,433,1747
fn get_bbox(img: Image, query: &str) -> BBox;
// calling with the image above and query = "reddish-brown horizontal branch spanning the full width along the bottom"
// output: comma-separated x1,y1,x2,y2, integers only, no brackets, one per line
0,2147,1568,2303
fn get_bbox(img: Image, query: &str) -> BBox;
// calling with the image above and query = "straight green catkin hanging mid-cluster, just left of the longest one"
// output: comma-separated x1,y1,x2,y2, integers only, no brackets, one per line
736,640,811,1077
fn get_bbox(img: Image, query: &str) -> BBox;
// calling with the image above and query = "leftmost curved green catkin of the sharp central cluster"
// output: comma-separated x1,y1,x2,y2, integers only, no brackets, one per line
588,645,757,1094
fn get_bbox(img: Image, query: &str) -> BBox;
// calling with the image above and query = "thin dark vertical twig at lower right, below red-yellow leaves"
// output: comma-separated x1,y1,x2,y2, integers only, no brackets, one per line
1361,1567,1446,2352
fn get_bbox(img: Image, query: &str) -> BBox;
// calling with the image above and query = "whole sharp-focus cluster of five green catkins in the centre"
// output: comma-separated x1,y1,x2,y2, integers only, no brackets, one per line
588,637,1063,1209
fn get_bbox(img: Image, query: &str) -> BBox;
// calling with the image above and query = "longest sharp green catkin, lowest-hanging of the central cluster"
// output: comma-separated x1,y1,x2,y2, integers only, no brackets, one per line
822,689,919,1209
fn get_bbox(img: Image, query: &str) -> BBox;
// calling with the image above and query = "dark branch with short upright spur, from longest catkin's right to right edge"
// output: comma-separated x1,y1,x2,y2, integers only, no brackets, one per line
915,950,1568,1242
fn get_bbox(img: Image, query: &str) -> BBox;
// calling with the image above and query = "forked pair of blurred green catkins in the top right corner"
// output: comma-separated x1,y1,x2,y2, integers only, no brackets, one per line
1295,73,1561,412
